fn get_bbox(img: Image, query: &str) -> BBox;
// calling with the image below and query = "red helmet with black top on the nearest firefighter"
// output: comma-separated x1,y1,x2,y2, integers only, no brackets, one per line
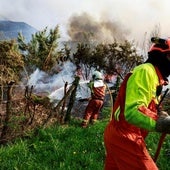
149,37,170,53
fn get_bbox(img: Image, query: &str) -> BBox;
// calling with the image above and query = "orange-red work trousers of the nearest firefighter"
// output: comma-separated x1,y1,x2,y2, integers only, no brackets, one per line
104,120,158,170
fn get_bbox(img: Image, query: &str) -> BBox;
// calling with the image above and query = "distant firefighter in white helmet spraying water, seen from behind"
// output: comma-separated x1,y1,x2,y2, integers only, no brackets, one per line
81,71,106,128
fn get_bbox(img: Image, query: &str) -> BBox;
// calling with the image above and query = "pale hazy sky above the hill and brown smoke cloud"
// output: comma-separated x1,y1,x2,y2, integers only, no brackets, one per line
0,0,170,44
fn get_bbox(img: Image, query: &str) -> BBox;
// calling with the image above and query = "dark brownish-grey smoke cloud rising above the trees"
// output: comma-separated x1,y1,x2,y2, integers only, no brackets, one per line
67,13,129,43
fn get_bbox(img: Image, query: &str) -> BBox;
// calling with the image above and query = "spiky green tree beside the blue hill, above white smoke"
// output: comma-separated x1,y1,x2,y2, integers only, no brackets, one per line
18,26,63,73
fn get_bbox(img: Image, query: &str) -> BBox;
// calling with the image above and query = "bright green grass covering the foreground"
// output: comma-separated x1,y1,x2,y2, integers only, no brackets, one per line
0,119,170,170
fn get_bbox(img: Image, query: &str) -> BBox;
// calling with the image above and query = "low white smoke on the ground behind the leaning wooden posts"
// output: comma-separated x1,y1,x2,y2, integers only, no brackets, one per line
28,62,90,103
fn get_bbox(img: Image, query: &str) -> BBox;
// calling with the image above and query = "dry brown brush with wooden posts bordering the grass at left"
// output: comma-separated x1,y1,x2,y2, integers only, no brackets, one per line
0,78,83,144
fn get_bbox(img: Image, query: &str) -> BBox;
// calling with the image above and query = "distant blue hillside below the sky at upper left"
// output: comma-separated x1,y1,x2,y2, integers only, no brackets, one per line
0,20,37,41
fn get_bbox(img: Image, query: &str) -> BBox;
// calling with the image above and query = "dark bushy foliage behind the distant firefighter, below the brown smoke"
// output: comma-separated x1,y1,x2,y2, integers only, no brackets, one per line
73,40,143,79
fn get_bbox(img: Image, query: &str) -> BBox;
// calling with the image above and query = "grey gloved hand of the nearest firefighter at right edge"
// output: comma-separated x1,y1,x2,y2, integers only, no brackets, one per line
156,111,170,134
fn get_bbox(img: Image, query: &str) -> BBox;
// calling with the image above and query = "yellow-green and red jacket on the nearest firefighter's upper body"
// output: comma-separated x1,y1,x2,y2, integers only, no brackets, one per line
113,63,167,131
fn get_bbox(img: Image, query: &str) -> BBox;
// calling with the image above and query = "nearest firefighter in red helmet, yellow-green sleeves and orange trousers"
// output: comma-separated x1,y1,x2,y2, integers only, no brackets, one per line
104,38,170,170
